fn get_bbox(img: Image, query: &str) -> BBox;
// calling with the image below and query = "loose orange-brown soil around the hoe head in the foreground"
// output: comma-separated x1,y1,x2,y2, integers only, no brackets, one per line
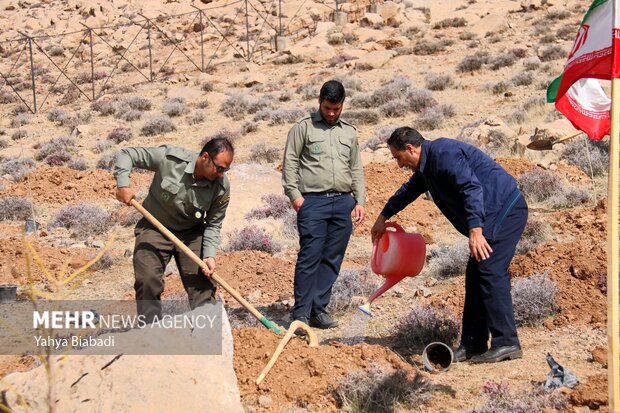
233,329,422,412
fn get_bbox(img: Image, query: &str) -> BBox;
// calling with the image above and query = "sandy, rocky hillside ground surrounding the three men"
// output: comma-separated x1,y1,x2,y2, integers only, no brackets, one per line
0,0,607,412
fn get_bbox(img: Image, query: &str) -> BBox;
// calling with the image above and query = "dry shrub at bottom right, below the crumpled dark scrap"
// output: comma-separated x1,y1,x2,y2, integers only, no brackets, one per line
472,381,568,413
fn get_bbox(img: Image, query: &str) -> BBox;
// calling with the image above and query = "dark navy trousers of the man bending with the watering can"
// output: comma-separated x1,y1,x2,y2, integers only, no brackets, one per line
461,196,528,348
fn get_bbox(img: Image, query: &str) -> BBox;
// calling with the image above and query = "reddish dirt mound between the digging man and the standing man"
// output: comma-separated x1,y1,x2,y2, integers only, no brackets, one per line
162,251,295,306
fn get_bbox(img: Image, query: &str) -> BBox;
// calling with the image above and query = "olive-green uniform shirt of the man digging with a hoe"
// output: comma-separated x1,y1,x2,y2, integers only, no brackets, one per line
114,145,230,258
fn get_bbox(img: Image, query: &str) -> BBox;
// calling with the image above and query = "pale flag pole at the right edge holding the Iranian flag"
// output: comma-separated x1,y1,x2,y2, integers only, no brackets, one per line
607,1,620,406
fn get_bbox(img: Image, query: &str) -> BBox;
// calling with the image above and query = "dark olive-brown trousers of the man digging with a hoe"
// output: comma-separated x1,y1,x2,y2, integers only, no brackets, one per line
133,218,215,323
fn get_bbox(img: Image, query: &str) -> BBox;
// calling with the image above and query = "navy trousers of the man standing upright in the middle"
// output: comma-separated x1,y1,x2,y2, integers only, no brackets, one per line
293,194,355,320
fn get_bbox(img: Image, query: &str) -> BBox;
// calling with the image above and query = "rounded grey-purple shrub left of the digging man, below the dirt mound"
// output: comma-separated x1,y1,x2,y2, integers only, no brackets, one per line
50,202,111,238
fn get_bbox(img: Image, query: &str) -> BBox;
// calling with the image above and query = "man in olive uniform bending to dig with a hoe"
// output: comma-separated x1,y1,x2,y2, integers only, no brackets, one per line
114,138,234,323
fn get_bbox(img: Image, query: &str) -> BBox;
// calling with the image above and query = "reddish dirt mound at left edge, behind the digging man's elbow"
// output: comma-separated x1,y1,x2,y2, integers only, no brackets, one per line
0,166,152,204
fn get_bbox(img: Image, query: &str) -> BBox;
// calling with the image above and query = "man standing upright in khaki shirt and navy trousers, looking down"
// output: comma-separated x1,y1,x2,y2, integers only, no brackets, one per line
282,80,366,328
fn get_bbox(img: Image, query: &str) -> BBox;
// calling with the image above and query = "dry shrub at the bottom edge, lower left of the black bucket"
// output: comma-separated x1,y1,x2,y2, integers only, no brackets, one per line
334,364,433,413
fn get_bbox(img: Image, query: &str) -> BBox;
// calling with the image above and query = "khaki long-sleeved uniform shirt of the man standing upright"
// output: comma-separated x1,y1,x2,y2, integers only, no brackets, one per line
282,112,366,205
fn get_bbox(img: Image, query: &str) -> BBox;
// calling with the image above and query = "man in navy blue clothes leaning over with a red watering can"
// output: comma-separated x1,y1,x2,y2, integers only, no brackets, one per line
371,127,527,363
